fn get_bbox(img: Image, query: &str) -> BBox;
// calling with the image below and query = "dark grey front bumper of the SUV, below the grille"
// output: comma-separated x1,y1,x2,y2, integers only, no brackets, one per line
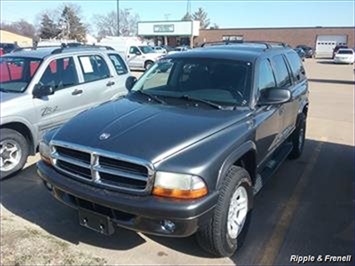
37,161,218,237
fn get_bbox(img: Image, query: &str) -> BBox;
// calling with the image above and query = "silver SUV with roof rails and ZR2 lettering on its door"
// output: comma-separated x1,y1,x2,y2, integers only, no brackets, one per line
0,47,130,179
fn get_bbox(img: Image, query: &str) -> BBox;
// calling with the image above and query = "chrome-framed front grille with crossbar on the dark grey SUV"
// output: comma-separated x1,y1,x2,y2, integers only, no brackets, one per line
51,142,153,193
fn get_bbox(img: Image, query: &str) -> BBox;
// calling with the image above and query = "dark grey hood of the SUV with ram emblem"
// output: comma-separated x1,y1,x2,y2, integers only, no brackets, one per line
54,98,252,164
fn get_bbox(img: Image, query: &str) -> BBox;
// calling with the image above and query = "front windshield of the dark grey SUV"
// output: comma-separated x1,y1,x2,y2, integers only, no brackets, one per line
132,58,252,107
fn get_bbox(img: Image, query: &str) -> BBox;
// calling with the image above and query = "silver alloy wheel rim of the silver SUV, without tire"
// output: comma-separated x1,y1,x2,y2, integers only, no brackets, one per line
0,140,22,171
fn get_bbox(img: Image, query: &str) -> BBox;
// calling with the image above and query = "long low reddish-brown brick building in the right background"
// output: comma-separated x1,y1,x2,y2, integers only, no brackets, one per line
194,27,355,48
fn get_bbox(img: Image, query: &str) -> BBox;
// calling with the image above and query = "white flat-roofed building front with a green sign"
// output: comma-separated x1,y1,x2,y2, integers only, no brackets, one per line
138,20,200,46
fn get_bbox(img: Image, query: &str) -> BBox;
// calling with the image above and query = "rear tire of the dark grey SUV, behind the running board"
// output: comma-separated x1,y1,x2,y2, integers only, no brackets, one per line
289,113,306,159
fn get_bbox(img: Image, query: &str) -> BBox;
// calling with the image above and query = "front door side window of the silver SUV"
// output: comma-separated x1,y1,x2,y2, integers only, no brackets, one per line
39,57,79,90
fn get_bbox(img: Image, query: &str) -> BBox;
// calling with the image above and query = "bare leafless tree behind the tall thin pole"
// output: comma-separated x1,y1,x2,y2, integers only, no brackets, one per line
95,9,139,38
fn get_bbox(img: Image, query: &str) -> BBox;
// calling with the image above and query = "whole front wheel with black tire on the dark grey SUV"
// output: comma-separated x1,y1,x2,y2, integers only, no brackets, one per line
196,166,253,257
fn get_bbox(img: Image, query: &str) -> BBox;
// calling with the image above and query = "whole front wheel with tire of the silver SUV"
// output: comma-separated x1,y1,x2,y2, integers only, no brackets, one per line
0,128,29,180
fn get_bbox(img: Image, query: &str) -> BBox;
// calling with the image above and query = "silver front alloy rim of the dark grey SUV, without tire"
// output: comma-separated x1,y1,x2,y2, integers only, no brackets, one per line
227,186,248,239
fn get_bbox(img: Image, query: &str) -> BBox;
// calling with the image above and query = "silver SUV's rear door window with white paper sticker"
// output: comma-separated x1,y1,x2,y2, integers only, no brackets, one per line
79,55,110,82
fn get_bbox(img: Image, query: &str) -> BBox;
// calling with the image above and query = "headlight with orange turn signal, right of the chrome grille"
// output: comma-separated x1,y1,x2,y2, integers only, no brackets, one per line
153,172,208,199
